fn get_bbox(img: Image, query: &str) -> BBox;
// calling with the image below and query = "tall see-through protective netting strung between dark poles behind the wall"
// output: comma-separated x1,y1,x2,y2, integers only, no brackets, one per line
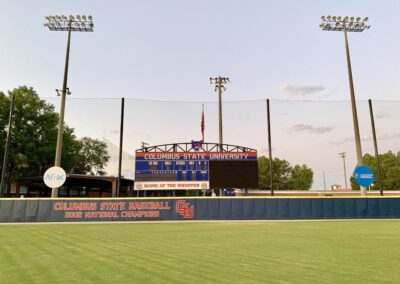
42,97,400,189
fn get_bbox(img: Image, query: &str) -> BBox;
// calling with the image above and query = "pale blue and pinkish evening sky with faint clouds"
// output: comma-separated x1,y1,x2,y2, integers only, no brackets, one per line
0,0,400,189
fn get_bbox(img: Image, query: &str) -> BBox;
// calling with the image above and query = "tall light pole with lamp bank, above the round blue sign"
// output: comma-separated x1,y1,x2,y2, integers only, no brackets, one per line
319,16,370,196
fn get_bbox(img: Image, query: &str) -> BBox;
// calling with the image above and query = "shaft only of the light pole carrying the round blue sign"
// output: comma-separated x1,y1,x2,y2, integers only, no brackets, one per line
343,25,367,196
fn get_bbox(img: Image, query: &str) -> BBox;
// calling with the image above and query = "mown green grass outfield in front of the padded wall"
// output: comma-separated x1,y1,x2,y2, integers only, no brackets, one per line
0,220,400,284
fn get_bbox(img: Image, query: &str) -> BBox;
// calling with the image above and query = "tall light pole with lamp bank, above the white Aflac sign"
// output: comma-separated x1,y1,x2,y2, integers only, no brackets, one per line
44,15,93,197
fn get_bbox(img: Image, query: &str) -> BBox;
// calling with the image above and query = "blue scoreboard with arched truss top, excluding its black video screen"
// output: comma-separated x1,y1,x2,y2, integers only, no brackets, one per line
134,141,257,190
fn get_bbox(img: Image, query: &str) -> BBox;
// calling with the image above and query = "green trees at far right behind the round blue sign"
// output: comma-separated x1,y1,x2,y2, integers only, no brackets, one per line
350,151,400,190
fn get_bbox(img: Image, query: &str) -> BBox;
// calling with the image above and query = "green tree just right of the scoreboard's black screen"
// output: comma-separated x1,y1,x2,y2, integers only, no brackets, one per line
258,156,314,190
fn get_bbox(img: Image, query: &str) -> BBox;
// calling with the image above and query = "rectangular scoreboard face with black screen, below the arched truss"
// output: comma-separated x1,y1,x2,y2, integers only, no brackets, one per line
135,152,257,190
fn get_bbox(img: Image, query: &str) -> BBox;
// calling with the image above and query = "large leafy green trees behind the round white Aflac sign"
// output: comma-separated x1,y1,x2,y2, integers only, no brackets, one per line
0,86,109,184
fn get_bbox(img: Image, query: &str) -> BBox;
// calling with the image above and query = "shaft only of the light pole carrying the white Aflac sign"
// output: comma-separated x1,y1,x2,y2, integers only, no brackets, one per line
51,21,71,198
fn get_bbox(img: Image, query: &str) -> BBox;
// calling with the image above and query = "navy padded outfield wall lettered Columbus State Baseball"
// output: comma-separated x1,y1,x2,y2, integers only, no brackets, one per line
0,197,400,223
